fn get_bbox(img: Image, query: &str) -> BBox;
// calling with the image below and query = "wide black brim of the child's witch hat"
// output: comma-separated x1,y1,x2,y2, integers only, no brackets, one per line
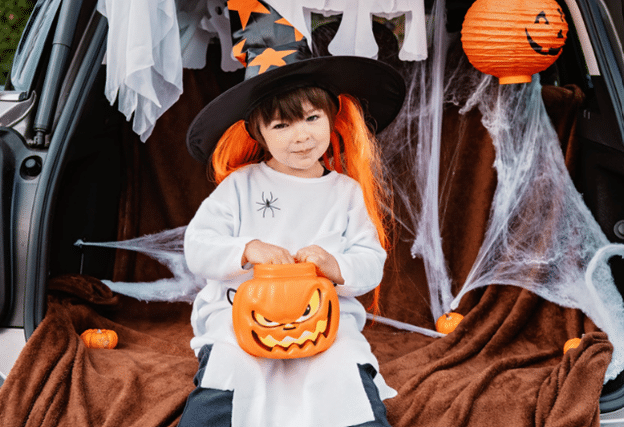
186,56,405,163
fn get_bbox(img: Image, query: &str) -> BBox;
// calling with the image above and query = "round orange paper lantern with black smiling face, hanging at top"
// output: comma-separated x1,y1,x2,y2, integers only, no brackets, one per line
461,0,568,84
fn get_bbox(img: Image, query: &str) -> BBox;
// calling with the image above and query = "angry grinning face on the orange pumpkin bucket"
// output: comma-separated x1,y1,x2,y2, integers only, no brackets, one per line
251,289,332,351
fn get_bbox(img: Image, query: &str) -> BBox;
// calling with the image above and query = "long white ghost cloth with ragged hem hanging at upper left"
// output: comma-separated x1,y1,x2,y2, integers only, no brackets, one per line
97,0,182,141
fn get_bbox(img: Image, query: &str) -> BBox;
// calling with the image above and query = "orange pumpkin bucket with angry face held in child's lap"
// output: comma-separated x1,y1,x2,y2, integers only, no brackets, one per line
232,263,340,359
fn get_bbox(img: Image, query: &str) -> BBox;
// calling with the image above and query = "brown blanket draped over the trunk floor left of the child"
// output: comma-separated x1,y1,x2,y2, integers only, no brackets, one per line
0,276,197,427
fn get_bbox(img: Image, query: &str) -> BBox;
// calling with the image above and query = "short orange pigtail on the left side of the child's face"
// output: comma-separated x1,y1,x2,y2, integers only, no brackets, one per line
212,120,268,184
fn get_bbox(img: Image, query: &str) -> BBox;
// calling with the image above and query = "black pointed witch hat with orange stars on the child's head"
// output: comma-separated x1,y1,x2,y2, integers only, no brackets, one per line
186,0,405,163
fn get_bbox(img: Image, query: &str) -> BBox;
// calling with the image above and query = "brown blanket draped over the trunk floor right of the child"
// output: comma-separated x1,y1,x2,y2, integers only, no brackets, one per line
366,286,612,426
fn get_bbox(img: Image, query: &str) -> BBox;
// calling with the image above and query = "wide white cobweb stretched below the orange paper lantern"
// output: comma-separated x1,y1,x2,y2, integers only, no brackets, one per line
450,74,624,380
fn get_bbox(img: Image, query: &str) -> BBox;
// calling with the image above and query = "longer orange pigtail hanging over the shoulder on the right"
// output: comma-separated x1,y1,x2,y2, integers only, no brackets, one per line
334,95,392,314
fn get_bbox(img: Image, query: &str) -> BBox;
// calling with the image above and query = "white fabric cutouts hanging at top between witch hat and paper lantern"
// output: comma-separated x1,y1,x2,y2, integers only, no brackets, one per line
266,0,427,61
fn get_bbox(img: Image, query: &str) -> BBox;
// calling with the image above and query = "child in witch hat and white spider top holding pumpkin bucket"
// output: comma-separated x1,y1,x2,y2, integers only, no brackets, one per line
180,3,404,427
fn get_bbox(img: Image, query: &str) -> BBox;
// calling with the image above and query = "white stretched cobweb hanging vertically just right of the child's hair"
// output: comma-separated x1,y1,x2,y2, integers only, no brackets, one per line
380,1,453,319
